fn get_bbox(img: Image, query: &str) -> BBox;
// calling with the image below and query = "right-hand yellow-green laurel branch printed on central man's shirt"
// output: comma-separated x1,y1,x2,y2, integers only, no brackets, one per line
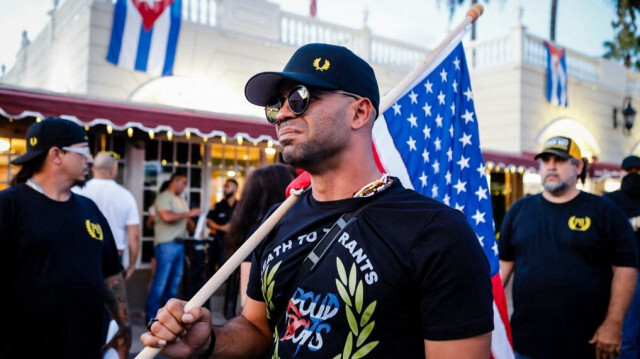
333,258,379,359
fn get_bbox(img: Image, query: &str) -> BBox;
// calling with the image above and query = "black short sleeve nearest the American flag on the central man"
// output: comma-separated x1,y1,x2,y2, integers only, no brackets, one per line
411,209,493,340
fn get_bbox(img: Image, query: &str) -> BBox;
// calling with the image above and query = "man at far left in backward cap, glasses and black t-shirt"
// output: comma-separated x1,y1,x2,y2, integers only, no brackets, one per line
0,118,131,358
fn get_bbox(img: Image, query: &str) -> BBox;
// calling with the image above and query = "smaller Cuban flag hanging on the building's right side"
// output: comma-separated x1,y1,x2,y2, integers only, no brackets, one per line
544,41,569,107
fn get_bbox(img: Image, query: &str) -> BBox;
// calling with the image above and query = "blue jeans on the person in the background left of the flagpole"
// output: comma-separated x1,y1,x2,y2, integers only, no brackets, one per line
146,242,184,318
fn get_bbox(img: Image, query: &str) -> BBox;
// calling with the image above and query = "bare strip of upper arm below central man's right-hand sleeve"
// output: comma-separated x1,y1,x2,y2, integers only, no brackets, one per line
424,332,491,359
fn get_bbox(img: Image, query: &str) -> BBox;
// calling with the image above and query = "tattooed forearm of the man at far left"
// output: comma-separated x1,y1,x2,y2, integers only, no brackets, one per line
104,273,131,358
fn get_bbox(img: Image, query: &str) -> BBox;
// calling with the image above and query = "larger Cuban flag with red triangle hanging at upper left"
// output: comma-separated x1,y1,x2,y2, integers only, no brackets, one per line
107,0,182,76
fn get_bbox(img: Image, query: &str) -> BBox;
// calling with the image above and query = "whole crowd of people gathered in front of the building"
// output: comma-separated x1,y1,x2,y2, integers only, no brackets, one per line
0,40,640,359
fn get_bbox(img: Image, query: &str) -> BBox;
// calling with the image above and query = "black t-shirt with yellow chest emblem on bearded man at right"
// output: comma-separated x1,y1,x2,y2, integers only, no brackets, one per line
498,192,638,358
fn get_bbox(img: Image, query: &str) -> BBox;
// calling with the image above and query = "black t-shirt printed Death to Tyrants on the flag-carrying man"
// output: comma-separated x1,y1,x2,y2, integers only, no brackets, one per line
247,179,493,358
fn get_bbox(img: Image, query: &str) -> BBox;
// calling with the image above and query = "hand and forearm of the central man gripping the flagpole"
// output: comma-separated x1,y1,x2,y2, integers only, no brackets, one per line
140,299,272,358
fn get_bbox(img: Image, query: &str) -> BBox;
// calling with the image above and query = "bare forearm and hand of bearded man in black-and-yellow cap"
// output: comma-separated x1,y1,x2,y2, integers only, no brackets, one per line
589,266,638,358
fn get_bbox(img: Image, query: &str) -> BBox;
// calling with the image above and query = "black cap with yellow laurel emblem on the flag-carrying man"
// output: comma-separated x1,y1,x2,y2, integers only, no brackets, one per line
244,43,380,113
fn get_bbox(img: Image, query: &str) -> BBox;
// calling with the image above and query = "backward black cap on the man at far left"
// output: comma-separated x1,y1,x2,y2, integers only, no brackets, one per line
11,117,89,165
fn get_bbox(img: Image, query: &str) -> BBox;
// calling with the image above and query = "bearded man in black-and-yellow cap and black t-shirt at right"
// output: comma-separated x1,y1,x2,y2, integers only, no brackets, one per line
498,136,638,359
